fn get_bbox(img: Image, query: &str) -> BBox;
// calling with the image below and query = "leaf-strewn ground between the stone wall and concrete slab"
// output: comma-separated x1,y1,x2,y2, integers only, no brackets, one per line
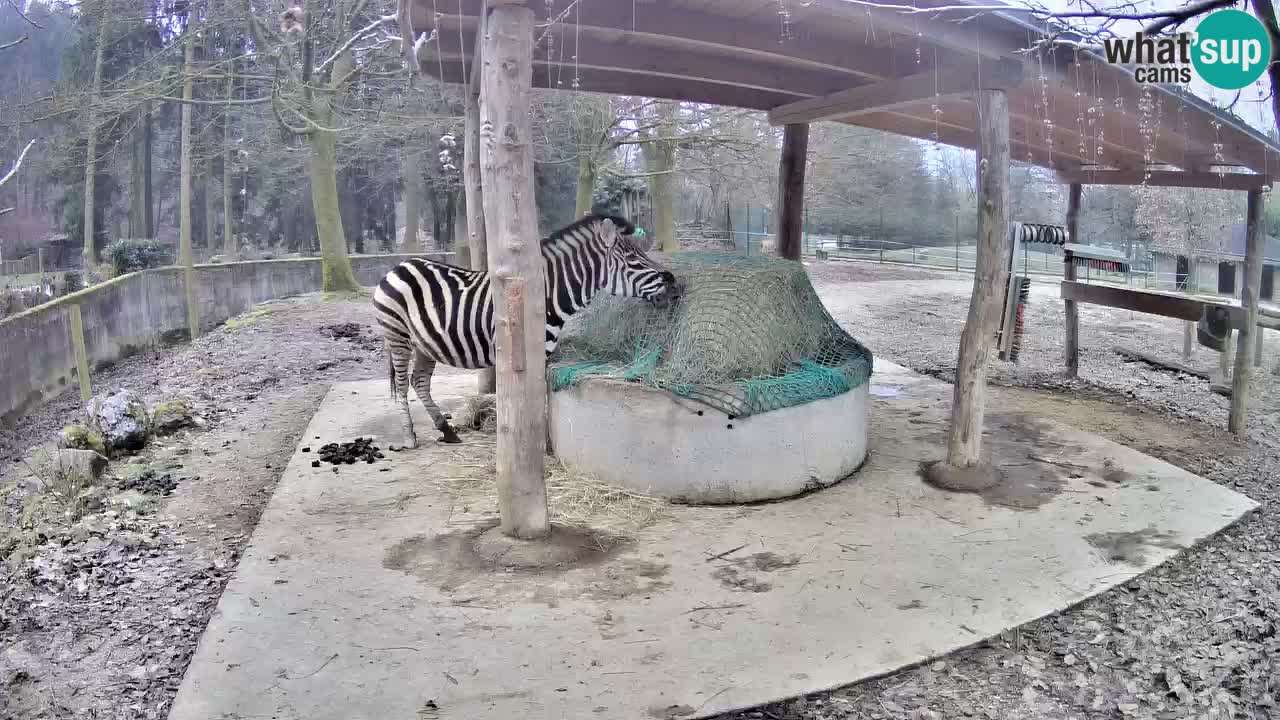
0,289,385,720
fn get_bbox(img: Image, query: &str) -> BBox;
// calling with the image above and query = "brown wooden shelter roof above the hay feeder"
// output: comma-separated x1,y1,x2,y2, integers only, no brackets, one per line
412,0,1280,176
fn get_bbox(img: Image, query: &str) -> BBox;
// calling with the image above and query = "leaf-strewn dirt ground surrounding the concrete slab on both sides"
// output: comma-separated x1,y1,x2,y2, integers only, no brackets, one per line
0,263,1280,720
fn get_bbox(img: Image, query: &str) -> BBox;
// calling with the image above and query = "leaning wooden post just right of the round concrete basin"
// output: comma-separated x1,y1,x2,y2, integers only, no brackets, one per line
947,90,1011,468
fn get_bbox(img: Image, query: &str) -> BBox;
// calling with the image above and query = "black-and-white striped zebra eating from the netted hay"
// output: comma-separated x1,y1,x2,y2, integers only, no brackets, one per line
374,215,676,447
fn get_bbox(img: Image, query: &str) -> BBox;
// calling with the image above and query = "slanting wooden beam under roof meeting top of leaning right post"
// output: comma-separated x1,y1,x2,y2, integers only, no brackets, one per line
769,60,1023,126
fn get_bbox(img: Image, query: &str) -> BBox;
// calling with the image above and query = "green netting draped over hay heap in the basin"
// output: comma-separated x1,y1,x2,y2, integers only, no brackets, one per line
548,252,872,418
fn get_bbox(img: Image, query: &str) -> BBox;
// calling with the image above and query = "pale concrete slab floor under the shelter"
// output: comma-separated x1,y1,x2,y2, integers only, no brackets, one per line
170,360,1256,720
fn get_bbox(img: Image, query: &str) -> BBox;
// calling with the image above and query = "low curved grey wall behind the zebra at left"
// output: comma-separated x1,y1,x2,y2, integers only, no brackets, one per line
0,254,448,423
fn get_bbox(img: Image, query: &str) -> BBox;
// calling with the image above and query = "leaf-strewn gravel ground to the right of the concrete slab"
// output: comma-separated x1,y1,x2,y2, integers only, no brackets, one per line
722,260,1280,720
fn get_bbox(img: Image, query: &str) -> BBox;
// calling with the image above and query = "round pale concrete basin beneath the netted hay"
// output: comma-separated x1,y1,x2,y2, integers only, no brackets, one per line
550,378,869,505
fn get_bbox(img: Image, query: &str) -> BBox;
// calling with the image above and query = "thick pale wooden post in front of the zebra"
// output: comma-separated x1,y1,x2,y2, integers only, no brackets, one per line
480,0,550,539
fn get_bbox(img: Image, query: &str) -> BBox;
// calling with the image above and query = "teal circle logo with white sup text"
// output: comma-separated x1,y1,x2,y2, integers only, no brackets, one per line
1192,10,1271,90
